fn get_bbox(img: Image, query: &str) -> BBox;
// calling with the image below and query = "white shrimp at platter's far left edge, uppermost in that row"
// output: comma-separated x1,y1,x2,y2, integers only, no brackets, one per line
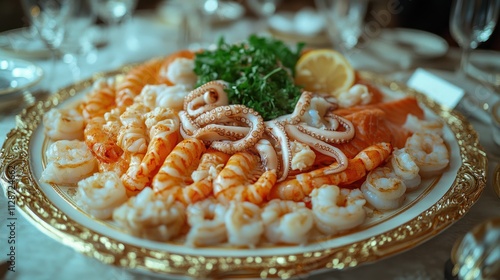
43,108,85,140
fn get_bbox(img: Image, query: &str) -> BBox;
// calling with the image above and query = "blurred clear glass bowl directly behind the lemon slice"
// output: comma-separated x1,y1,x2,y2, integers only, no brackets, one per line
315,0,368,54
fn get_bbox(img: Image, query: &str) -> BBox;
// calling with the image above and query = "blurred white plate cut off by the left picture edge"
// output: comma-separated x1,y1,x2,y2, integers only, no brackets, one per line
0,58,43,99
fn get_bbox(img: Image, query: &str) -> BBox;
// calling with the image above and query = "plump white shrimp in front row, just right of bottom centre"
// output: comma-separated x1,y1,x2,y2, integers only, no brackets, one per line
261,199,314,244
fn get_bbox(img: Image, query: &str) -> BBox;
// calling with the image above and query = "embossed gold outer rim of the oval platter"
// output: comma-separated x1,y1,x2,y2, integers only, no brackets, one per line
0,67,487,278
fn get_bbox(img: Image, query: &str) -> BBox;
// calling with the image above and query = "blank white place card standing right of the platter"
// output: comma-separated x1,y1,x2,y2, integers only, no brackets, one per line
407,68,465,109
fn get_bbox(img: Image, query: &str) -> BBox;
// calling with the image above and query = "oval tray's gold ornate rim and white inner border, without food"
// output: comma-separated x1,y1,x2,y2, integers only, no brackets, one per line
0,68,487,278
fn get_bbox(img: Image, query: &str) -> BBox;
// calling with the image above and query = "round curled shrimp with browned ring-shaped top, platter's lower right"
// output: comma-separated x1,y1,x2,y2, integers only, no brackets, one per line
360,167,406,210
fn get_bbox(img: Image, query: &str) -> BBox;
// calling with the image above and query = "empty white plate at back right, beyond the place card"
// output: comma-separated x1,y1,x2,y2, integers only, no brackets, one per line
379,28,448,58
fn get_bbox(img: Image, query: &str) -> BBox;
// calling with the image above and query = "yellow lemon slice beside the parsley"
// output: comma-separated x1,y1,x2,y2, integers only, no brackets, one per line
295,49,355,96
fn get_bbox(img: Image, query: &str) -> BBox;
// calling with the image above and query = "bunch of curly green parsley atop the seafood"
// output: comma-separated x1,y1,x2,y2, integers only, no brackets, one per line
194,35,304,120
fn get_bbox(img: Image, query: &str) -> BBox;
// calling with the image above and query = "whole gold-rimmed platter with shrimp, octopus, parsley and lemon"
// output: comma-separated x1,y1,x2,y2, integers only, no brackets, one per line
0,36,486,278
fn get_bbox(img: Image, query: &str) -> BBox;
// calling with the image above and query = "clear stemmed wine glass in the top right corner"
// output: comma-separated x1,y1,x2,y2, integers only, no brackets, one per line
450,0,500,77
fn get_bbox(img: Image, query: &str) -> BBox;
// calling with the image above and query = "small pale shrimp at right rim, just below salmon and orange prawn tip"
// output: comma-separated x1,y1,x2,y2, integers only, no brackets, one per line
389,148,422,191
